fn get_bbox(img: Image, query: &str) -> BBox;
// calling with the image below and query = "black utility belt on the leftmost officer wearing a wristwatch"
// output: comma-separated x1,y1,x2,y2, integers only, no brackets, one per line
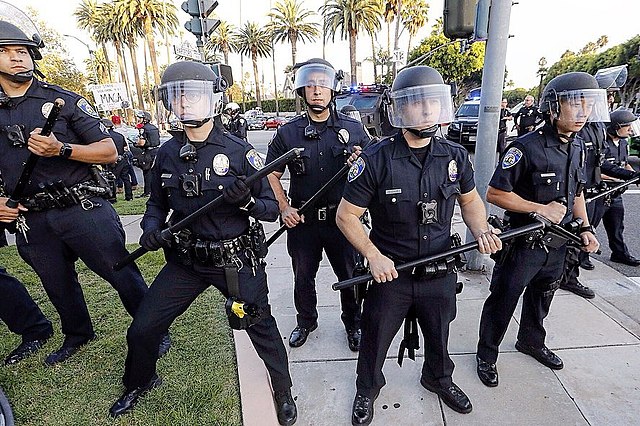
20,179,111,212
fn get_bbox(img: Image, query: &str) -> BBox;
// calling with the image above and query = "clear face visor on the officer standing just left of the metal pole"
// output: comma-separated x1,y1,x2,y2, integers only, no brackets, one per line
389,84,453,129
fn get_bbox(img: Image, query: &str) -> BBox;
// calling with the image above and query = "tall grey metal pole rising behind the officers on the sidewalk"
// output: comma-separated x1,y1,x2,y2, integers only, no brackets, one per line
467,0,512,270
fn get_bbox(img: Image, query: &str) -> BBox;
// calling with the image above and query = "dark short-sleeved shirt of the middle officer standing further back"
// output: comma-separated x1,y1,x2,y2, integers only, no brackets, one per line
267,113,370,207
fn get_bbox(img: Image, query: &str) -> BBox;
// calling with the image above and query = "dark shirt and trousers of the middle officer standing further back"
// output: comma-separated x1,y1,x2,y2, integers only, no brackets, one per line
267,113,369,332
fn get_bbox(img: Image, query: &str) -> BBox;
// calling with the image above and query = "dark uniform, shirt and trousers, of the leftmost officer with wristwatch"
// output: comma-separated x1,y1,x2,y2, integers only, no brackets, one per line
0,78,147,347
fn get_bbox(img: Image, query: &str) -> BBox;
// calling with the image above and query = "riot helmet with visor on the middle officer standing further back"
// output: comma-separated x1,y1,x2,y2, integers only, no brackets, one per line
293,58,344,114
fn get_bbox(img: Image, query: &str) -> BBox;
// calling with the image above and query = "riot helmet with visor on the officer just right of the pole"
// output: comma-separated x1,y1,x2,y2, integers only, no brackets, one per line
540,72,609,123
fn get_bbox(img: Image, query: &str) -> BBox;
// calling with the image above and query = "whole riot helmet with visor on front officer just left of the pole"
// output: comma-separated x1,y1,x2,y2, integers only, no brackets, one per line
385,65,453,138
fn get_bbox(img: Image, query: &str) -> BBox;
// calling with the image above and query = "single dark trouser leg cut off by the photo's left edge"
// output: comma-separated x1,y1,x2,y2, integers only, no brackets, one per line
0,266,53,342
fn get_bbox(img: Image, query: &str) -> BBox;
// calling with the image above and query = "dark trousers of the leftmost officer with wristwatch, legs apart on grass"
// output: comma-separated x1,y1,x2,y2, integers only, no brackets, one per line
16,198,147,346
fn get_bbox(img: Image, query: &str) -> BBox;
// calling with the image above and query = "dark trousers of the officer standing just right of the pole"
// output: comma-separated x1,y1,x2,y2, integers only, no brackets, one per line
478,242,566,363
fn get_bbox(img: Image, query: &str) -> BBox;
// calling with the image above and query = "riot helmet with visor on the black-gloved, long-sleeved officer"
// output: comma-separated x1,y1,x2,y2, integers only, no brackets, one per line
157,61,223,127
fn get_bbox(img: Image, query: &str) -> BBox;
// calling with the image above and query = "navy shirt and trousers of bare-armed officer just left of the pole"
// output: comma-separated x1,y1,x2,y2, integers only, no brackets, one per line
344,133,475,399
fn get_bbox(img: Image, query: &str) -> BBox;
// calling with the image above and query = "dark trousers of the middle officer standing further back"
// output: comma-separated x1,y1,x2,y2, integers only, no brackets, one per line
287,217,360,330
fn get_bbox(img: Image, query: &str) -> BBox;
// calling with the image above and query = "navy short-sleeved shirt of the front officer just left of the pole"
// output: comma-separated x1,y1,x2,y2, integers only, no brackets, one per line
344,133,475,261
